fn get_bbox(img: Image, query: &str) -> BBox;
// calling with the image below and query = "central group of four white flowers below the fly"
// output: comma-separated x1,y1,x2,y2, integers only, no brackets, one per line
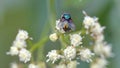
47,33,94,63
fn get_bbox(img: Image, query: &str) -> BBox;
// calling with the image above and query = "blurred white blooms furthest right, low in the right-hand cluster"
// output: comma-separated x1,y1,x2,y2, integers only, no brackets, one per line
94,43,113,57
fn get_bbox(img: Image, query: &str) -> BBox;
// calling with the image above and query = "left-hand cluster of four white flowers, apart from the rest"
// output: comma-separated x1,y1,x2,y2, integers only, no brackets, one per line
7,30,31,63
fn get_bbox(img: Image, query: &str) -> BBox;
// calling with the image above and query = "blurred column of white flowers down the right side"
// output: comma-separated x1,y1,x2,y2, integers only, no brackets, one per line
83,12,113,68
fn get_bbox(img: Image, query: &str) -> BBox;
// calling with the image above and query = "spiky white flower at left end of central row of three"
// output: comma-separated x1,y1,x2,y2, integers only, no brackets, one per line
46,50,62,63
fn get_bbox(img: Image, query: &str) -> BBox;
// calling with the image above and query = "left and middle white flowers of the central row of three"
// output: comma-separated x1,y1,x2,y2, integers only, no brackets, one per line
46,46,76,63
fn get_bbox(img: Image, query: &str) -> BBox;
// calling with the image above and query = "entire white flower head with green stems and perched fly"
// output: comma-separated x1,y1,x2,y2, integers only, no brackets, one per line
7,11,113,68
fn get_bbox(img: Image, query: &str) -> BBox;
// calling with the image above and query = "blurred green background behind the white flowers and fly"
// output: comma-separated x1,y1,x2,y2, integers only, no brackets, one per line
0,0,120,68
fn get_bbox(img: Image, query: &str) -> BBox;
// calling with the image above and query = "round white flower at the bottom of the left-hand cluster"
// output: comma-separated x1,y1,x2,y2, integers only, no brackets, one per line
19,48,31,63
